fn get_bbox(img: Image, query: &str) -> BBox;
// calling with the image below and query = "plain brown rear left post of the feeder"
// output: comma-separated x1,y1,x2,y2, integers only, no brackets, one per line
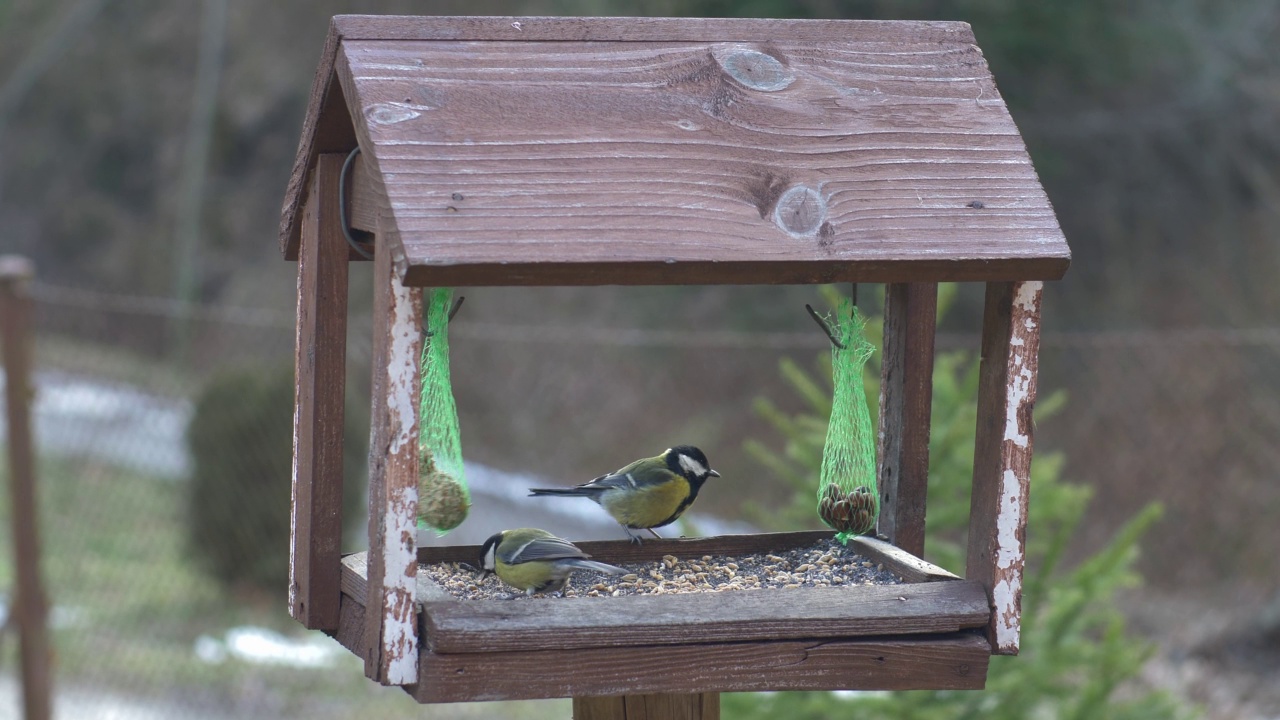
289,154,348,630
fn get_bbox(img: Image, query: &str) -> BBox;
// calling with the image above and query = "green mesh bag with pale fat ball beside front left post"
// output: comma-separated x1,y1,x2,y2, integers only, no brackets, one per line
417,287,471,536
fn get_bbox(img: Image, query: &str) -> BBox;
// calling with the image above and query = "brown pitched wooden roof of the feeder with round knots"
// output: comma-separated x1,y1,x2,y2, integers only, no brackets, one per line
280,15,1070,284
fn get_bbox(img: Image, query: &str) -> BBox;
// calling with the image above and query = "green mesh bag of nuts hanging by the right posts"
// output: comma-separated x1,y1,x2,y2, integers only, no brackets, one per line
818,297,879,543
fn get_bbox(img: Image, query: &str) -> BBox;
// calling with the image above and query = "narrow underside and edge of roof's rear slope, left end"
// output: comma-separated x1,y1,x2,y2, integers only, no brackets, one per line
280,22,356,260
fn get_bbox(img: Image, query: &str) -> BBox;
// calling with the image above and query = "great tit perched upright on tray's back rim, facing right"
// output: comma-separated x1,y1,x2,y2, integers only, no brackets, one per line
529,445,719,544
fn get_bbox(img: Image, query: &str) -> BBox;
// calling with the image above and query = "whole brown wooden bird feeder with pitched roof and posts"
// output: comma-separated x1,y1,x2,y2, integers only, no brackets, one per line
280,15,1070,715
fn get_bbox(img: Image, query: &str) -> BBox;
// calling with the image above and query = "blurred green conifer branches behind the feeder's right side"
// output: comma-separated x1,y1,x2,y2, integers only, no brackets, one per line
723,285,1189,720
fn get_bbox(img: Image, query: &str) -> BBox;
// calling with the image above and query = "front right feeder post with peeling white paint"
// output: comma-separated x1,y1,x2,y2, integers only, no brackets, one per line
966,282,1043,655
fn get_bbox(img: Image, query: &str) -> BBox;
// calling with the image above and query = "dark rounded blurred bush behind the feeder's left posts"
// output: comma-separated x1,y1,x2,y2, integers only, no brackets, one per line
187,366,366,592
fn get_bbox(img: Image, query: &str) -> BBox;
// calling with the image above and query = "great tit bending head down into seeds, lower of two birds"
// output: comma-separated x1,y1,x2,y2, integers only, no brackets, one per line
480,528,626,594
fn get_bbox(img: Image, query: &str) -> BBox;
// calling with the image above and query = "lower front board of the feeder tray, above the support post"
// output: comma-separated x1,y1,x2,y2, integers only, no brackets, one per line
411,634,989,702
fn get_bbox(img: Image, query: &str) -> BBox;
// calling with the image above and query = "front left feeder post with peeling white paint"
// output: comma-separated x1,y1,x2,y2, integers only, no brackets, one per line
365,234,422,685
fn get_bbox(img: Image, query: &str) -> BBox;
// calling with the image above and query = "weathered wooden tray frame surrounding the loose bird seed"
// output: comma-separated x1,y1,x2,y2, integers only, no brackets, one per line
335,532,991,702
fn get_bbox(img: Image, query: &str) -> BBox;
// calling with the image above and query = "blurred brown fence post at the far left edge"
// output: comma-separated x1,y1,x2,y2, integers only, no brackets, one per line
0,255,52,720
